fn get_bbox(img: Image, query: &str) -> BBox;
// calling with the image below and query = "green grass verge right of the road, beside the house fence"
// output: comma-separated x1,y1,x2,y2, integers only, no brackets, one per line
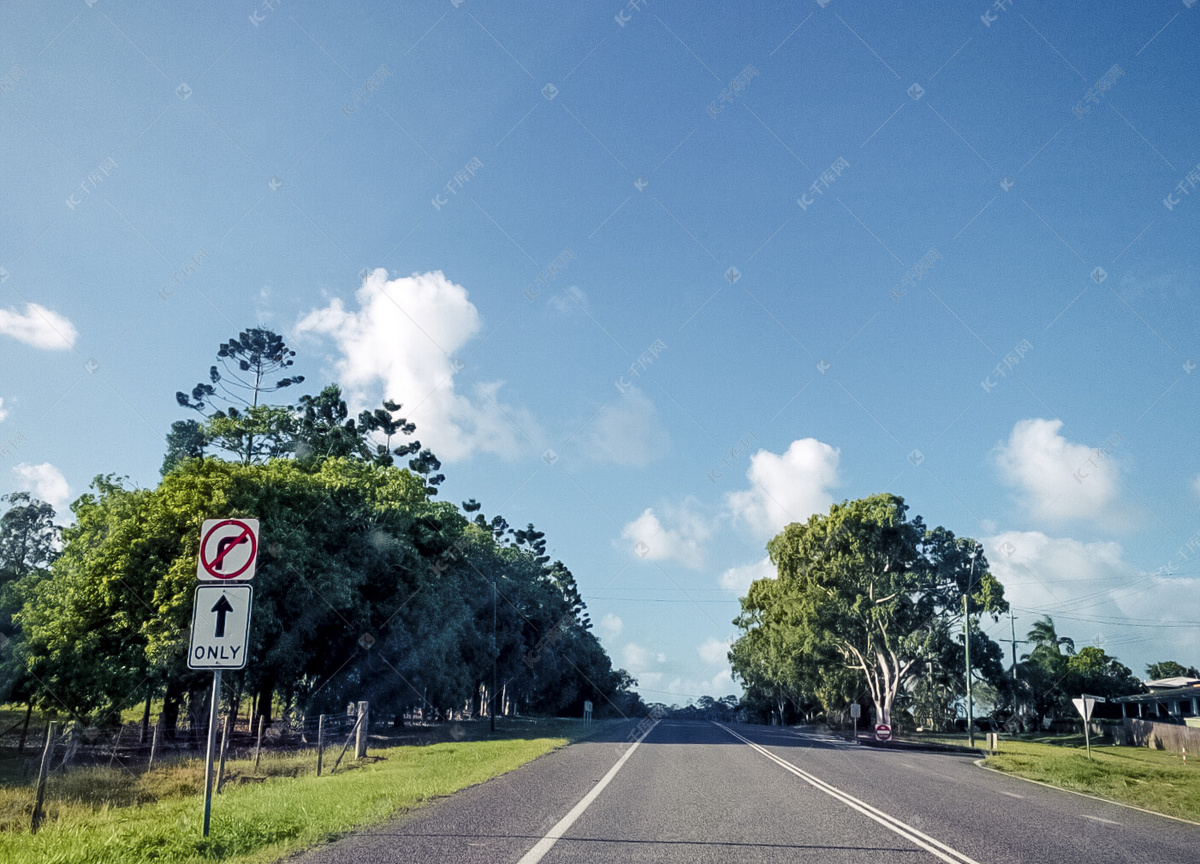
906,734,1200,822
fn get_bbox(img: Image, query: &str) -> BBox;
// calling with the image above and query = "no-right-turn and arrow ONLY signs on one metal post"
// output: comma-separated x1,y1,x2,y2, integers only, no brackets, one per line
187,518,258,836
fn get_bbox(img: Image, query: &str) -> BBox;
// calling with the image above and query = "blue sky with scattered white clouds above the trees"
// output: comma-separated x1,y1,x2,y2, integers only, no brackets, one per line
0,0,1200,703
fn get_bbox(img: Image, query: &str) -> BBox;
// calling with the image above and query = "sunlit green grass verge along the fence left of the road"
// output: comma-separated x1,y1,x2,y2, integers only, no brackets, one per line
0,724,606,864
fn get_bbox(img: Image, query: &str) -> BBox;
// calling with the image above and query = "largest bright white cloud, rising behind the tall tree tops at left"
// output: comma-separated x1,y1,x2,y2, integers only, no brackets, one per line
296,269,539,461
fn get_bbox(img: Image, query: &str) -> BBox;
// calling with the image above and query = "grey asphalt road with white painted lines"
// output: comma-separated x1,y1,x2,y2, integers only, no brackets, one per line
292,720,1200,864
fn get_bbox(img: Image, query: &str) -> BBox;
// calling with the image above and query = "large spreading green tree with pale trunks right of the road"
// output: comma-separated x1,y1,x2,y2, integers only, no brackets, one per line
731,493,1007,722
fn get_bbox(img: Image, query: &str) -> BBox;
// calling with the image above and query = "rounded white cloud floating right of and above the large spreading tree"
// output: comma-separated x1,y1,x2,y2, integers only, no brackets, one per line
995,418,1120,521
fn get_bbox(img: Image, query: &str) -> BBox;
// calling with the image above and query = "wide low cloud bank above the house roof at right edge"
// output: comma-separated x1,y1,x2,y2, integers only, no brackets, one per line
982,532,1200,676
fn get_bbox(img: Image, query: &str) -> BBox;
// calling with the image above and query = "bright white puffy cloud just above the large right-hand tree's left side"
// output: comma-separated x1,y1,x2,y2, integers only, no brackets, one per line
727,438,840,538
